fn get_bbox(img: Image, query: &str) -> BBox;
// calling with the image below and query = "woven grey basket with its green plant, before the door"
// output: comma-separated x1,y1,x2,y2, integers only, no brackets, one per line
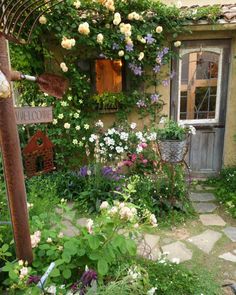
157,120,196,163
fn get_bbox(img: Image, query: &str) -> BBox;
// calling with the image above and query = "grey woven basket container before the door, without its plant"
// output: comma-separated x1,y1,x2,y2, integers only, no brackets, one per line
158,140,188,163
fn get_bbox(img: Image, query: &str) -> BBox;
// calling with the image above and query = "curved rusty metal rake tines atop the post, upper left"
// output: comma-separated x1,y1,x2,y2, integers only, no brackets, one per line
0,0,65,44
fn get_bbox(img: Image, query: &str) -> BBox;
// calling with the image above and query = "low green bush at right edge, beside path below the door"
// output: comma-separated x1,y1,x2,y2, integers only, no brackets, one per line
207,167,236,218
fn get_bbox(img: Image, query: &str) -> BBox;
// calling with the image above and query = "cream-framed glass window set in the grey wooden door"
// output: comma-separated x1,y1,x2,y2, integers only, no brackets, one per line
178,48,222,123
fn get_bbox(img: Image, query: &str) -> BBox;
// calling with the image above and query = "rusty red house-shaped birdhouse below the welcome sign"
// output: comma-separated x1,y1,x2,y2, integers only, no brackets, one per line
23,130,55,177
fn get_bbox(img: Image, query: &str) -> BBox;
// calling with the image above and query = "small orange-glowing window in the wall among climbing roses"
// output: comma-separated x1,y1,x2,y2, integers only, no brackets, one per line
95,59,123,94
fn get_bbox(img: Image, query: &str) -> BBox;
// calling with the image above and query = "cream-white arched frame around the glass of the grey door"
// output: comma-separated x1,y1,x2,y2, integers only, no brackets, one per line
177,46,224,125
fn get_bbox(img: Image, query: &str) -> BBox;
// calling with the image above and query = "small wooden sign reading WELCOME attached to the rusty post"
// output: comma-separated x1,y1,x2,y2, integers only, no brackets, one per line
15,107,53,125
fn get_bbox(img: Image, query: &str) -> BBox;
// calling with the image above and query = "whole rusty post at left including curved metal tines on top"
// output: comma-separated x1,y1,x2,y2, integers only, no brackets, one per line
0,0,64,263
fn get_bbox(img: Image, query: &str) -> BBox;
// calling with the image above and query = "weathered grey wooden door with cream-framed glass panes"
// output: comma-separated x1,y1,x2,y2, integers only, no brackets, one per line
171,40,230,176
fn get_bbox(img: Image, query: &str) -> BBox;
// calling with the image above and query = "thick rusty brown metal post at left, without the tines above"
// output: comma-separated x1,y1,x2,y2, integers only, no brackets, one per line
0,36,33,263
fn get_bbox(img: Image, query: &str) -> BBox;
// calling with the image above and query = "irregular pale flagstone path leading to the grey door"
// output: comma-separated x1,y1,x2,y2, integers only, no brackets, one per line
136,185,236,294
